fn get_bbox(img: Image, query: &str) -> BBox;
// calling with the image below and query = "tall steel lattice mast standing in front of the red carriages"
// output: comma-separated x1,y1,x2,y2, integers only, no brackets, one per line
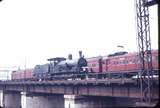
136,0,153,103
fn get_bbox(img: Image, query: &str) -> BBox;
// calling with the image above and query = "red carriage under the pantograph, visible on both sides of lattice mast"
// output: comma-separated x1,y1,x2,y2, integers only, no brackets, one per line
103,50,158,72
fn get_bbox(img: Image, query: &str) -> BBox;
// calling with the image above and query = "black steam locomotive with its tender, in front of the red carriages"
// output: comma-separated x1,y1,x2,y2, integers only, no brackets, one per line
33,51,87,80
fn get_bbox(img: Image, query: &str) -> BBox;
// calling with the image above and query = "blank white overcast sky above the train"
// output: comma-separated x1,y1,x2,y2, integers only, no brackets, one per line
0,0,158,68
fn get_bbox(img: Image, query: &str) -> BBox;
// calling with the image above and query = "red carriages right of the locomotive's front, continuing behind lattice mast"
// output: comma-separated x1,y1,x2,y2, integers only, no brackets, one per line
87,50,159,76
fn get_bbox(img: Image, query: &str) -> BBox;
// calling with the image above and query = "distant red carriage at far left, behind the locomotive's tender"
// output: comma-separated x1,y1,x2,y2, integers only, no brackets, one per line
11,69,34,80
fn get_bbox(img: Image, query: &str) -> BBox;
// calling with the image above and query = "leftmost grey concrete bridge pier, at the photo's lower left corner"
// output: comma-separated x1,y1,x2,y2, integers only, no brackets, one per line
3,91,21,108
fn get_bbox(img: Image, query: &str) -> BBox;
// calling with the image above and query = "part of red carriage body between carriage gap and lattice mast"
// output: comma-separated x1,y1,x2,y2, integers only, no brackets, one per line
106,53,140,72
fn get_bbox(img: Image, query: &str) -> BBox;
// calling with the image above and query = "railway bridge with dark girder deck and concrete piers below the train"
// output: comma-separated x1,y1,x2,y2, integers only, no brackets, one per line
0,79,159,108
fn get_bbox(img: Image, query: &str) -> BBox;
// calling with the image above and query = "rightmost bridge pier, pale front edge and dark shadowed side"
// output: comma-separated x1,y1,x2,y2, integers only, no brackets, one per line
64,95,135,108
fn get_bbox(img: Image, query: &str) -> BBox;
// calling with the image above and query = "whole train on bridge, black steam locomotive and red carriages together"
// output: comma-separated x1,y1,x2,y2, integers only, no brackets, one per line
11,50,159,80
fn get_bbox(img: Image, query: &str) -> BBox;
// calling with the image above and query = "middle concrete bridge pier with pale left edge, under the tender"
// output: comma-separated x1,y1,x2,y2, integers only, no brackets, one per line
22,92,64,108
